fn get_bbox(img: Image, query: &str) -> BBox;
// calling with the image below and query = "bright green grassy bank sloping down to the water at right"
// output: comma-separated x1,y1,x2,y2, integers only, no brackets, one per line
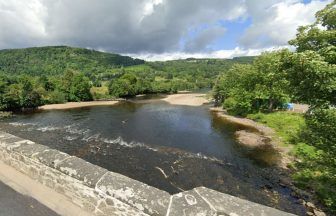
247,112,336,214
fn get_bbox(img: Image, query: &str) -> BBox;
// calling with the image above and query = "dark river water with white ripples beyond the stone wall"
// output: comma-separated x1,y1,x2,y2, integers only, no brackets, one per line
0,100,305,215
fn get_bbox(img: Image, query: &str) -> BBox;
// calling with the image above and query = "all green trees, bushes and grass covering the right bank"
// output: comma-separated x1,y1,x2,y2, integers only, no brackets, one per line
214,1,336,214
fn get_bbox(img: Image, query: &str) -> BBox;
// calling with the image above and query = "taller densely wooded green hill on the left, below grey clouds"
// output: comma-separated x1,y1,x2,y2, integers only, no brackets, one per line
0,46,145,76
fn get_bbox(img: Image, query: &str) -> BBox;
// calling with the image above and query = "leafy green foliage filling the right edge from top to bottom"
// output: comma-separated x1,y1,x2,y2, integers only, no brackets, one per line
285,1,336,214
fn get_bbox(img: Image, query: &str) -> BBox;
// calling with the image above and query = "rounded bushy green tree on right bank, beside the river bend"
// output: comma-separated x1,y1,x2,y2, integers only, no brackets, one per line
213,50,289,116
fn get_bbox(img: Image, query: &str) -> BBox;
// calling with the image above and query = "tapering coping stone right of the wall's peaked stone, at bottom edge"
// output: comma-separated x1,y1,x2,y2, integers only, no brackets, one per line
194,187,293,216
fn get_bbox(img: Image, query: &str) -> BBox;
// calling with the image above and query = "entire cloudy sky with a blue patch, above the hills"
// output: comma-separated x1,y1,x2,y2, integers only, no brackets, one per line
0,0,331,60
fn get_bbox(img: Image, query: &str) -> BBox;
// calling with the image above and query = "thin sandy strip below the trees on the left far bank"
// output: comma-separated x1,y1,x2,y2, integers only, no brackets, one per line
39,101,119,110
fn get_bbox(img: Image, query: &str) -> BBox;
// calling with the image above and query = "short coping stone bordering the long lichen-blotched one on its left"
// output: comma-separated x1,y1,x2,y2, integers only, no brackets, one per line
56,157,108,188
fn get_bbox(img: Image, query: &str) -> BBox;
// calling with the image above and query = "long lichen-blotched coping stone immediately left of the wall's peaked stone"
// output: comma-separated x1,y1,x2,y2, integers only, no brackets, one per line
97,172,170,215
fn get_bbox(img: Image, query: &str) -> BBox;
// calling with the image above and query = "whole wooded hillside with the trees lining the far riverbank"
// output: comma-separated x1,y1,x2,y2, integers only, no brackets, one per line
0,46,253,110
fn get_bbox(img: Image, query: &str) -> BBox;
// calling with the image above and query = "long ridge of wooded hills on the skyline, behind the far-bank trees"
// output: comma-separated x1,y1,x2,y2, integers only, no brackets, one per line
0,46,255,81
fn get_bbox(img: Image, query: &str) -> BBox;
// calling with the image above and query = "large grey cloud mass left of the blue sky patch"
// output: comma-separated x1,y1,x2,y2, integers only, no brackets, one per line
0,0,242,53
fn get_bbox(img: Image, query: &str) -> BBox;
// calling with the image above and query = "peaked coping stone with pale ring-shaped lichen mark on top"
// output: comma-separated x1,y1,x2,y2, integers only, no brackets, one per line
167,190,216,216
